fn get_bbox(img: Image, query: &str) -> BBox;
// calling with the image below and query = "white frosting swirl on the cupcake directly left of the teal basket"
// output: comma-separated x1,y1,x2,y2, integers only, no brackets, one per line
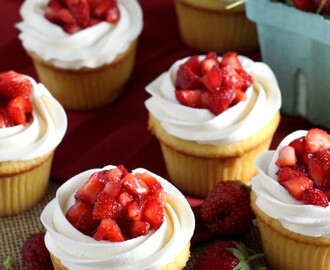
145,56,281,145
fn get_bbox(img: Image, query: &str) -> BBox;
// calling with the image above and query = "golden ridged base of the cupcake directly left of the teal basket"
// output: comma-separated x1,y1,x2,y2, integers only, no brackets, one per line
149,111,280,197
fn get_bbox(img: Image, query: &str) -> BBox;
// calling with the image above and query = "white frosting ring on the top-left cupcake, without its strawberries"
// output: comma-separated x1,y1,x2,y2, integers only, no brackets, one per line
16,0,143,69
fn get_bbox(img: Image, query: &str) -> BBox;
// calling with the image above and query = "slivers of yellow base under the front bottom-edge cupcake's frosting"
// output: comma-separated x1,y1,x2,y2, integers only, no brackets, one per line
50,242,190,270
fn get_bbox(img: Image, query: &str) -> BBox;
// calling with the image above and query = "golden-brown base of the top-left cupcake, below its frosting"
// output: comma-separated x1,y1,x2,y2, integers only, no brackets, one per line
28,40,137,110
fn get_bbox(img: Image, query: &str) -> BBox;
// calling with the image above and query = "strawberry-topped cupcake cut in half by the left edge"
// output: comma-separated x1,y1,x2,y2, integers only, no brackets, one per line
0,71,67,216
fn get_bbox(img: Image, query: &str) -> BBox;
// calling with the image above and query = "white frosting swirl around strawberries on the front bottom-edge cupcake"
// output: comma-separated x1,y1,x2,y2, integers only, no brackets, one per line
41,165,195,270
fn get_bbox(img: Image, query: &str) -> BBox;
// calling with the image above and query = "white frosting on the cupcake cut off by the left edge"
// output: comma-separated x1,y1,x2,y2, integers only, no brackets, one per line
0,75,67,162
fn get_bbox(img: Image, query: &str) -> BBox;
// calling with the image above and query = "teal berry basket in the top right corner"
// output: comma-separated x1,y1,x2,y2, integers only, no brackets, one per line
246,0,330,128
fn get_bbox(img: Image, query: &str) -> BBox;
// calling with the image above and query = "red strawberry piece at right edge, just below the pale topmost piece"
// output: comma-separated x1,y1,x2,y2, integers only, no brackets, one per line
307,149,330,188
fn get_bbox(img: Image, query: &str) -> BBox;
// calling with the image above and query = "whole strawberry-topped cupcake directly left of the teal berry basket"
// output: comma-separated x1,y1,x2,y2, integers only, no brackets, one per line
145,52,281,197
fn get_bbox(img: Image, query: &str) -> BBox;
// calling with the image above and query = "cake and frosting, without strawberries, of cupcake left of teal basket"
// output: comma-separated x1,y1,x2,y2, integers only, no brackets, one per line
146,53,281,197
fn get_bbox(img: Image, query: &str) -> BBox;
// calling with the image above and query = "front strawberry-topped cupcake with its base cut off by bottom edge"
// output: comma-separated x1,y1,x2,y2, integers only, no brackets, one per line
41,165,195,270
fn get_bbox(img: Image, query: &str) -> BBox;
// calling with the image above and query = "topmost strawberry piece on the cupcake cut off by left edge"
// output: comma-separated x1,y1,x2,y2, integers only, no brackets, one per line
0,71,32,99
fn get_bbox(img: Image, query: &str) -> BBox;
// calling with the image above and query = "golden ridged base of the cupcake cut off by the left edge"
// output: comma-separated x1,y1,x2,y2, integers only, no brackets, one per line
0,151,53,217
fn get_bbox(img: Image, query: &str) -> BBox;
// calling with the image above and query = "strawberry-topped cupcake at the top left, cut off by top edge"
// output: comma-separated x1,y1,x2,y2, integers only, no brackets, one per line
16,0,143,110
